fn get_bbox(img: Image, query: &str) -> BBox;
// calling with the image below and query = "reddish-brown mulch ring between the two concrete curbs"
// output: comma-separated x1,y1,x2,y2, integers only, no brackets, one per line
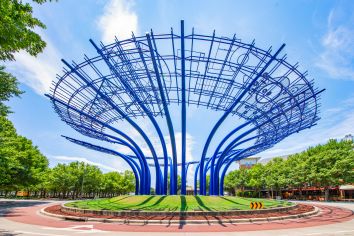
44,204,314,220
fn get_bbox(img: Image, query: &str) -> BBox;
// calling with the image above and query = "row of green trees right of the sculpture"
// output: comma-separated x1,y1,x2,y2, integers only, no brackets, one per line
224,140,354,199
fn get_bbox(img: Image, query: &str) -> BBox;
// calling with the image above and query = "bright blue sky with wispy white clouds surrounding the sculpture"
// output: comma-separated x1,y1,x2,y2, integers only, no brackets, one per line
7,0,354,184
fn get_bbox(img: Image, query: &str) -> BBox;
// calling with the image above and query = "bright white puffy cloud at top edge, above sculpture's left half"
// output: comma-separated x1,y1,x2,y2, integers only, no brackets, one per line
97,0,138,43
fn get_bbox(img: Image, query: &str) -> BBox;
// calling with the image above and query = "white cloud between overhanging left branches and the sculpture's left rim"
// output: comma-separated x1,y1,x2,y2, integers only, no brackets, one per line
6,34,61,95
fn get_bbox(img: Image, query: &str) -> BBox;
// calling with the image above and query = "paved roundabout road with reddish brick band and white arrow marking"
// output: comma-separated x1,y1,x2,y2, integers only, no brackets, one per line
0,200,354,236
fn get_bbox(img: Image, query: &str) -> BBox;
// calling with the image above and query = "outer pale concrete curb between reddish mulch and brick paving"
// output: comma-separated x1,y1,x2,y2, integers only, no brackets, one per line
40,206,320,225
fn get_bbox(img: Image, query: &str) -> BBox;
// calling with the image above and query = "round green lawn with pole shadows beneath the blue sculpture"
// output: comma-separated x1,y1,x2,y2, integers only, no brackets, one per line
66,195,291,211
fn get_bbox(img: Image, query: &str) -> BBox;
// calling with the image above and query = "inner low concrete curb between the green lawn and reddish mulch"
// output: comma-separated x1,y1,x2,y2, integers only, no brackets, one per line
61,203,298,217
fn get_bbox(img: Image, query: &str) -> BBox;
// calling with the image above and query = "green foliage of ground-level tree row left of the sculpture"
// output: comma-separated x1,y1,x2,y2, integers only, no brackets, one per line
0,116,135,198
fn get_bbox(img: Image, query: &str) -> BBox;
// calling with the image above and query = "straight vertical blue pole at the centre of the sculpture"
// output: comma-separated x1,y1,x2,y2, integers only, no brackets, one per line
181,20,187,195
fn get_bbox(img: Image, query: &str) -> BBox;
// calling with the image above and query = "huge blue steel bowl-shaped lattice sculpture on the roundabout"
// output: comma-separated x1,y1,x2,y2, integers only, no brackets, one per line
47,21,323,195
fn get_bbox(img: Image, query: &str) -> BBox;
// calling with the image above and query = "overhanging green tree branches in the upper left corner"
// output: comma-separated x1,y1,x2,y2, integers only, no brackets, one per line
0,0,56,116
